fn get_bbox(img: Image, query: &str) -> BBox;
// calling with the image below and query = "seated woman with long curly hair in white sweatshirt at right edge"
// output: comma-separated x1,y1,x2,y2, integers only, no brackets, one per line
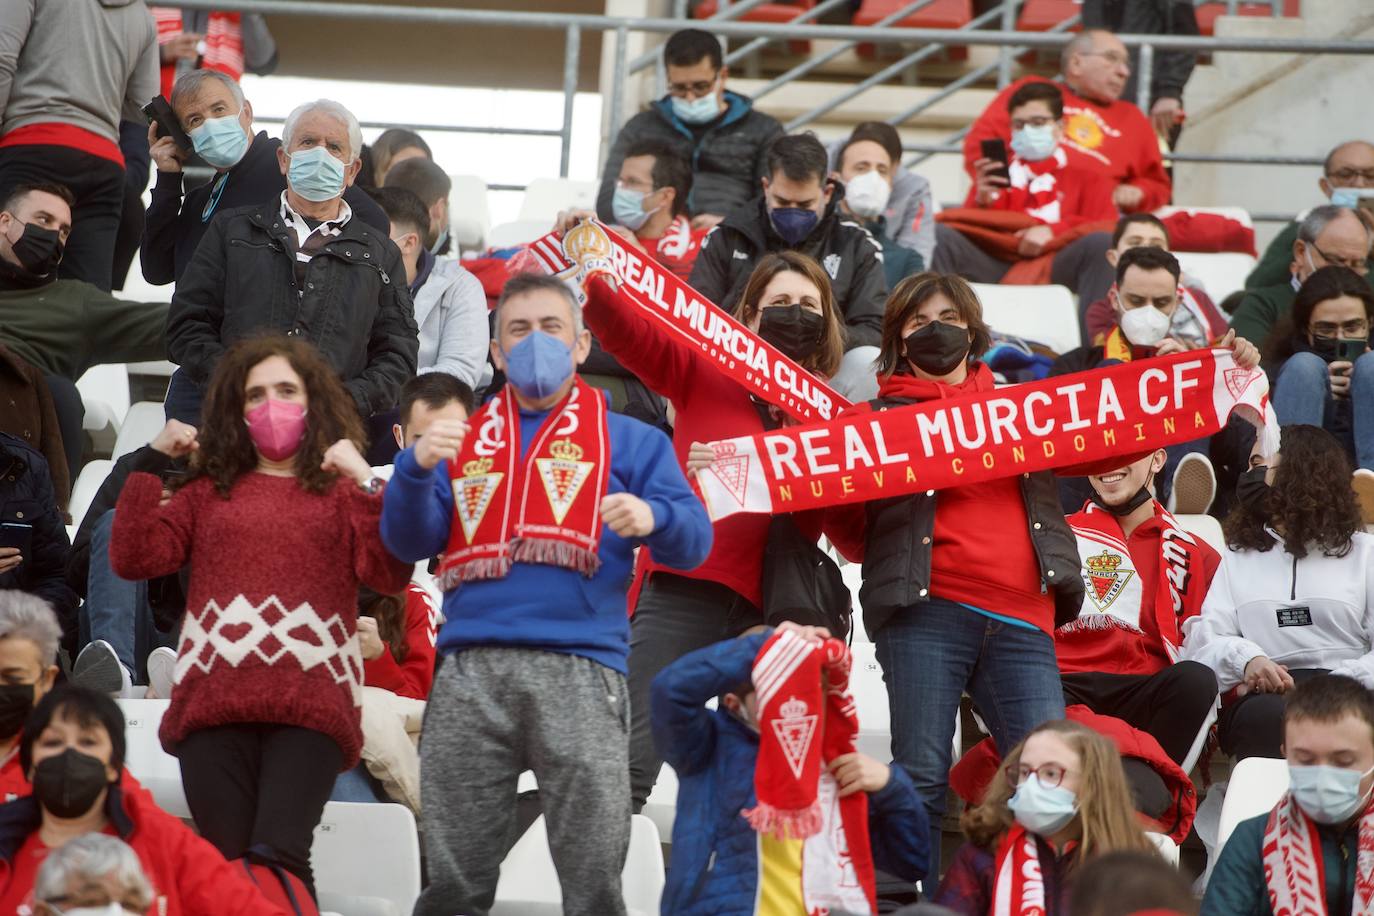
1183,426,1374,759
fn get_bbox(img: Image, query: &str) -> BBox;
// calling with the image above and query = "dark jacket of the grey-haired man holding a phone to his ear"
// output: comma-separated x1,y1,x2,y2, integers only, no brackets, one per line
139,130,392,286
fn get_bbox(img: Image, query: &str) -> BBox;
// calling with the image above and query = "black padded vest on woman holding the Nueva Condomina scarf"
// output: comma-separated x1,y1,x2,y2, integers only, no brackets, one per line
859,398,1083,633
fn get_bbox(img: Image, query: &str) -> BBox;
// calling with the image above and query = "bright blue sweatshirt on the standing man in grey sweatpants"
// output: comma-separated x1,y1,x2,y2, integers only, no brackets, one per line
382,401,712,674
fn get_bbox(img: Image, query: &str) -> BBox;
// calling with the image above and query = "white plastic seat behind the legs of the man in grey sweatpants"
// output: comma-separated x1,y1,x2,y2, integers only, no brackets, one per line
491,814,664,916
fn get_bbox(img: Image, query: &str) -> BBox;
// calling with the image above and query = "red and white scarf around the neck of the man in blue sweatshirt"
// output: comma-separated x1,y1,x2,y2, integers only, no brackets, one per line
436,379,610,589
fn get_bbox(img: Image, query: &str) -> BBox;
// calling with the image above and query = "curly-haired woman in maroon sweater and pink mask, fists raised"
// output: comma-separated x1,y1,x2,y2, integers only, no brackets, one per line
110,336,411,886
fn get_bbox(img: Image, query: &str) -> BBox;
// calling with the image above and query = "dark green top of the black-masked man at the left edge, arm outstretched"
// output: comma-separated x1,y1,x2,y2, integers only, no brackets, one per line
0,271,168,382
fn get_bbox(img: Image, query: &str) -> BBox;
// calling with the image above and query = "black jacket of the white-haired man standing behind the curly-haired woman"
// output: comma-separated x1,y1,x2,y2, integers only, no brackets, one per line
168,201,419,417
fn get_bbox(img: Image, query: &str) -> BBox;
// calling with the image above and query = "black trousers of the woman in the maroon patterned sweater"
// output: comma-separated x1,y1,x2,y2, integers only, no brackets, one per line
177,725,344,894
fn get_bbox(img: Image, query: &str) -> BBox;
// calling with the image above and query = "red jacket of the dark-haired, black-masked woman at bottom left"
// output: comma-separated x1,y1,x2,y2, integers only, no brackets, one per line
0,787,286,916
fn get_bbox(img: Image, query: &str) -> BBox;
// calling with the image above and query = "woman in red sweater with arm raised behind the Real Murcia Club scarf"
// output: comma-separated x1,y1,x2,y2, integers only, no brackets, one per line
583,251,844,810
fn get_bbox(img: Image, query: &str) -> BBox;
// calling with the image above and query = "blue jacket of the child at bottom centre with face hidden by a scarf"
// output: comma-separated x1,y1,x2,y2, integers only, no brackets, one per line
650,633,930,916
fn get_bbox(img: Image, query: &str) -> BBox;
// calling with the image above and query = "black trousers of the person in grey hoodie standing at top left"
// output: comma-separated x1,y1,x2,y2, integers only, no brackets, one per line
0,146,124,293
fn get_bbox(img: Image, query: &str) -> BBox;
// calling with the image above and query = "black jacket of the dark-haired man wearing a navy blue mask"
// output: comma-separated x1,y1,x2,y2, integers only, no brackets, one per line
690,192,888,350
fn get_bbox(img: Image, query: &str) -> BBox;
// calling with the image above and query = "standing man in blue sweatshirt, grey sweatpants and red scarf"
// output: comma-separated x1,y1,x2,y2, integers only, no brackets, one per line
382,275,712,916
